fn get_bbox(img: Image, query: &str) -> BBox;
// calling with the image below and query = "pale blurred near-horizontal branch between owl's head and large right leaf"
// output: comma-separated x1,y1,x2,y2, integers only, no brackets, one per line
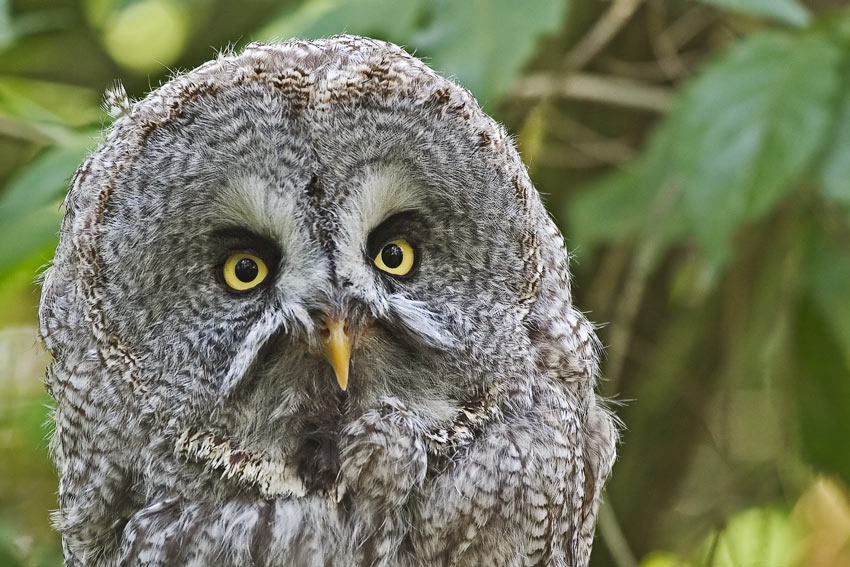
508,73,672,113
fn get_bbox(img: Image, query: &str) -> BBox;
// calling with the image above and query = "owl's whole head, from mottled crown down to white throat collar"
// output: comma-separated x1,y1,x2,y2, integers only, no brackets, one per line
41,36,596,506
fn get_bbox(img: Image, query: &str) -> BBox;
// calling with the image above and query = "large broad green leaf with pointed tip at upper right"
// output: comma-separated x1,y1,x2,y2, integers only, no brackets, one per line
642,32,842,264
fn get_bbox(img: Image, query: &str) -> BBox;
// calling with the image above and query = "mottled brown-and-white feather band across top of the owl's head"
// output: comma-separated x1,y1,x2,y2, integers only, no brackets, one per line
67,36,548,254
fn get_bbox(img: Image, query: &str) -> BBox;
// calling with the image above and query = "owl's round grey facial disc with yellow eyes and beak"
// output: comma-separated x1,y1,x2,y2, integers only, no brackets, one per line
83,44,548,494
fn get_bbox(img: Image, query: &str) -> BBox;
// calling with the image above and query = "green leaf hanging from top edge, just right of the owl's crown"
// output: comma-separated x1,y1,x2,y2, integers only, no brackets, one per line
413,0,569,106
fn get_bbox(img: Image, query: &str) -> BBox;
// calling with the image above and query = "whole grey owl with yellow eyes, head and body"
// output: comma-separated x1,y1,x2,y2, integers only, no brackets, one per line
40,36,617,567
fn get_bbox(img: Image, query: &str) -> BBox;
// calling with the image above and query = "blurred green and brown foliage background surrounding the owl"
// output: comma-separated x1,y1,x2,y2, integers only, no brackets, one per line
0,0,850,567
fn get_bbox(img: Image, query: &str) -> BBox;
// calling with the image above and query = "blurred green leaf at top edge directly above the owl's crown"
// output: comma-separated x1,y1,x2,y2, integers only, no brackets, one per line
257,0,423,43
